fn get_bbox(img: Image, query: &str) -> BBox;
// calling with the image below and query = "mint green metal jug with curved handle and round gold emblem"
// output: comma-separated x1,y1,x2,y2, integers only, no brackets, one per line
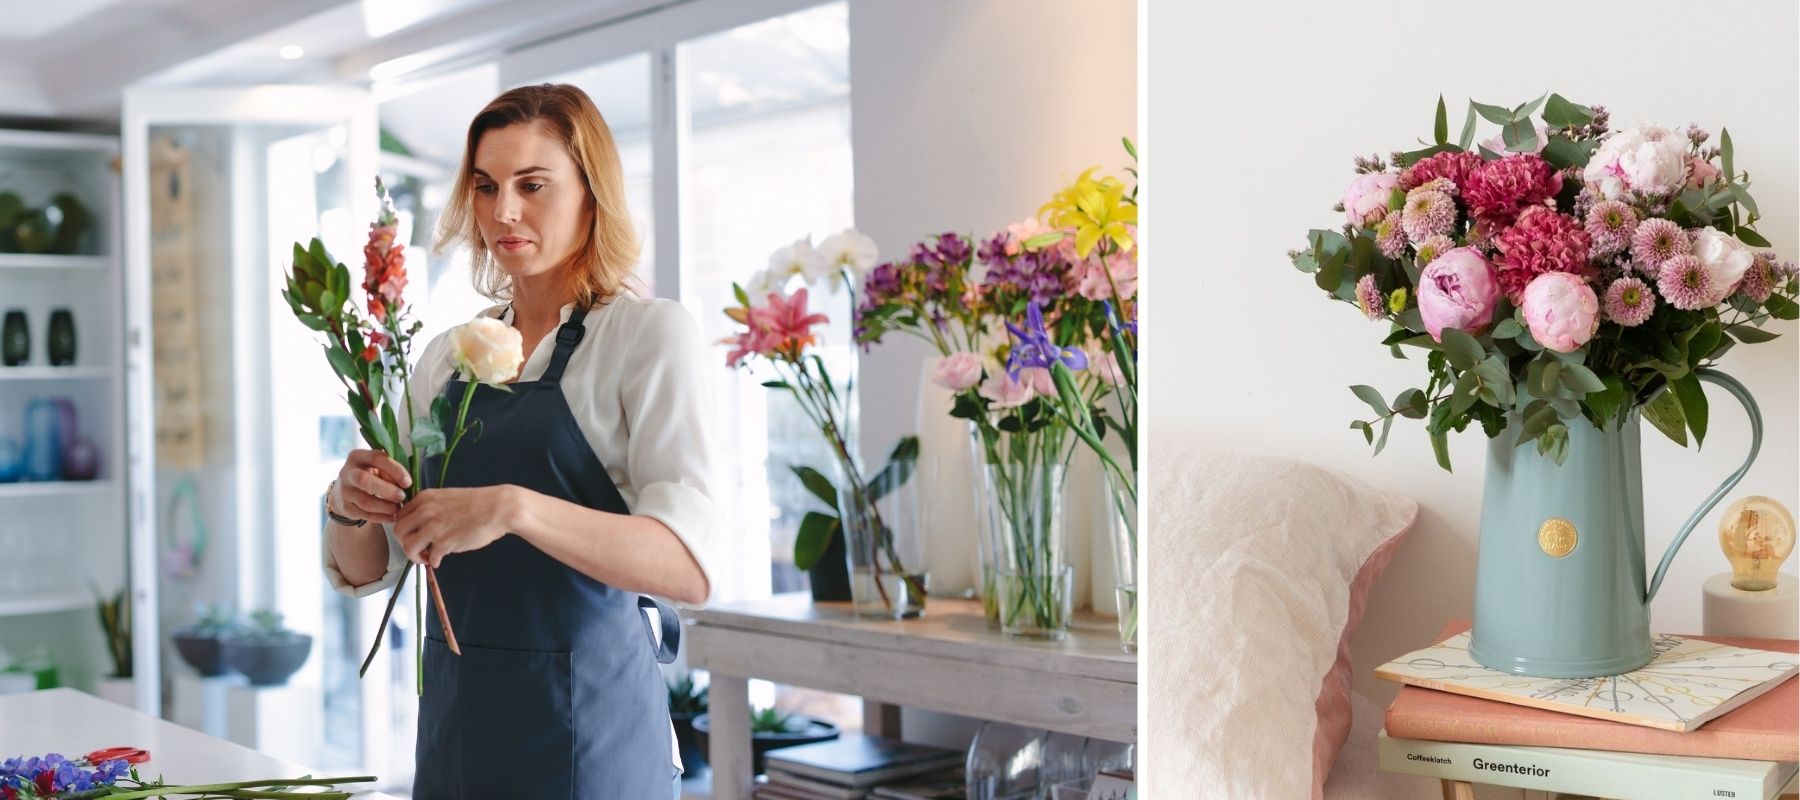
1469,369,1762,677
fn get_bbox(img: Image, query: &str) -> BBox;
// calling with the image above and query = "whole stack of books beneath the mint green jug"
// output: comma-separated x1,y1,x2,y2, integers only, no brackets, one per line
1375,623,1800,800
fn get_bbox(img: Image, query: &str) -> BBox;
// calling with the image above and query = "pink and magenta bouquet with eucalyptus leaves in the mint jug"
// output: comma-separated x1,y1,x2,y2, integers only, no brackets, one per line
1289,94,1800,470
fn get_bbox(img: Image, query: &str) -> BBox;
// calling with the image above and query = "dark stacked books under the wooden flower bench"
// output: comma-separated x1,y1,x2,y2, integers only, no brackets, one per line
751,735,963,800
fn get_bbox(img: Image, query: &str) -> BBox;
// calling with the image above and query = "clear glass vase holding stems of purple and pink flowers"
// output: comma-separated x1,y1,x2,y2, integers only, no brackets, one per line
976,423,1075,640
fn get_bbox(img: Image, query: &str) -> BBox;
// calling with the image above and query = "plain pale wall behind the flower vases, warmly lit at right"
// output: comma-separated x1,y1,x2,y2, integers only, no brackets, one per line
850,0,1138,746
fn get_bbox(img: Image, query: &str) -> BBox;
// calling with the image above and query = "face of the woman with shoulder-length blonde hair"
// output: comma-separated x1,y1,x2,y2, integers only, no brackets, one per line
473,123,594,285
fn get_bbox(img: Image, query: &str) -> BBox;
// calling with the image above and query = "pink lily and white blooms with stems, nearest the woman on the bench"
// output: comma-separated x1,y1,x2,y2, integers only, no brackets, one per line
720,231,927,609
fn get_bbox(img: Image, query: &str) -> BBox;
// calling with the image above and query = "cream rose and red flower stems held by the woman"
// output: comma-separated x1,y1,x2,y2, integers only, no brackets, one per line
281,178,524,692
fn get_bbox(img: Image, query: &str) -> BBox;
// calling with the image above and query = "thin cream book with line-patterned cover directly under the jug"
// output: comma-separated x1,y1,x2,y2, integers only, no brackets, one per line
1375,632,1800,732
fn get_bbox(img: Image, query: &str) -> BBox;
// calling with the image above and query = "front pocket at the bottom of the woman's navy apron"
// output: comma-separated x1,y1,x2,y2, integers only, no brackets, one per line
418,640,574,798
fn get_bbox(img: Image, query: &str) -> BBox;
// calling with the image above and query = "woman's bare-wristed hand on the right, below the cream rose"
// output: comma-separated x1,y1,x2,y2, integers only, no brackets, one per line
394,485,517,569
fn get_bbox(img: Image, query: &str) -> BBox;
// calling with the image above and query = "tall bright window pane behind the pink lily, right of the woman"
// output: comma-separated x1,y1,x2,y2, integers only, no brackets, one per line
682,4,855,598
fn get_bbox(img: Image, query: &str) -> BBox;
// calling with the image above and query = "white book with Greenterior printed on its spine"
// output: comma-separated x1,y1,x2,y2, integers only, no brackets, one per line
1379,732,1796,800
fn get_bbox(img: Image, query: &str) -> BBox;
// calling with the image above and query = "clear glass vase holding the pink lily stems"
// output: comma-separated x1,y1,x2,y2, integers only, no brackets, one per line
837,443,931,620
